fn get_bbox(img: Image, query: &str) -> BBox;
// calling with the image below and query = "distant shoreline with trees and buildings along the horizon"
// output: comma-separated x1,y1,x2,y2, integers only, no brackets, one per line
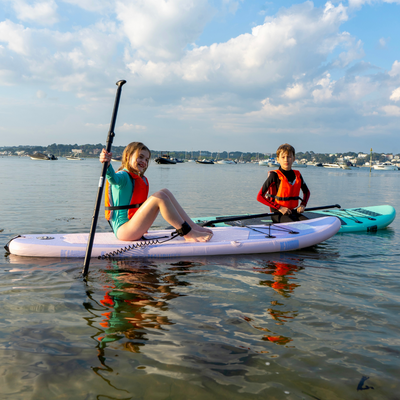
0,143,391,165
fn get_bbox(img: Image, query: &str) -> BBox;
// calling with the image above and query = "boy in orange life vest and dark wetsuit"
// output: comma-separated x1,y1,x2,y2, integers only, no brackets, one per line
257,143,310,223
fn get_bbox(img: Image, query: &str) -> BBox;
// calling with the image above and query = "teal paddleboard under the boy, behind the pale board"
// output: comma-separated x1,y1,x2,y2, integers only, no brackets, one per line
193,205,396,233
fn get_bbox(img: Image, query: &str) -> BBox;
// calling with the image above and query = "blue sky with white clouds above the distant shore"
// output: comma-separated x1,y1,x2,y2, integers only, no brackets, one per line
0,0,400,154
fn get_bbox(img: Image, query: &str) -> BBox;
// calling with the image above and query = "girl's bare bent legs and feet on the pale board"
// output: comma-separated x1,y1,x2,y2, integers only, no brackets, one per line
117,191,212,242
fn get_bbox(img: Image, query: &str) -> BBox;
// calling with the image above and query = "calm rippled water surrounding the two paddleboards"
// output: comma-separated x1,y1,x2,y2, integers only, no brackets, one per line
0,157,400,400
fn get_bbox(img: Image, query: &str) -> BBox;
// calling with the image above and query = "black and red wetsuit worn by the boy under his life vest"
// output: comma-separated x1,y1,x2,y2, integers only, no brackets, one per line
257,168,310,223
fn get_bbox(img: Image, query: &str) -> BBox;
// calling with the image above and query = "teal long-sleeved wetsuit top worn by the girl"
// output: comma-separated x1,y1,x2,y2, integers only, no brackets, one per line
105,164,148,236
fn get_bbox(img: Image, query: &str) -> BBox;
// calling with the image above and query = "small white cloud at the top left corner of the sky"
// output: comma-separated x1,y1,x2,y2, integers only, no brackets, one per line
12,0,58,25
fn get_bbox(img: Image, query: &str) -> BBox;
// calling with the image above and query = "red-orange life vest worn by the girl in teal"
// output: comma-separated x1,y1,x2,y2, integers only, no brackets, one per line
104,171,149,221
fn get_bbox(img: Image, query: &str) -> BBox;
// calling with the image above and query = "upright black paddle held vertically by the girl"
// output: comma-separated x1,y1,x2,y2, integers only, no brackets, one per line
82,80,126,278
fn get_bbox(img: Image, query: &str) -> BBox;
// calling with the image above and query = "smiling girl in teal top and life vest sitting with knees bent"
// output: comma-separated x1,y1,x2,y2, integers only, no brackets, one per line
100,142,213,242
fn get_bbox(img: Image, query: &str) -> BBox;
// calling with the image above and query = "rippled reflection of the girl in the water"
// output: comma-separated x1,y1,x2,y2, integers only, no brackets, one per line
88,260,199,353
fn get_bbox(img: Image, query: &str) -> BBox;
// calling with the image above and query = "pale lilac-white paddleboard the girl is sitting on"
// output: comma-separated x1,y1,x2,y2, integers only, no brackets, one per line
8,217,340,258
